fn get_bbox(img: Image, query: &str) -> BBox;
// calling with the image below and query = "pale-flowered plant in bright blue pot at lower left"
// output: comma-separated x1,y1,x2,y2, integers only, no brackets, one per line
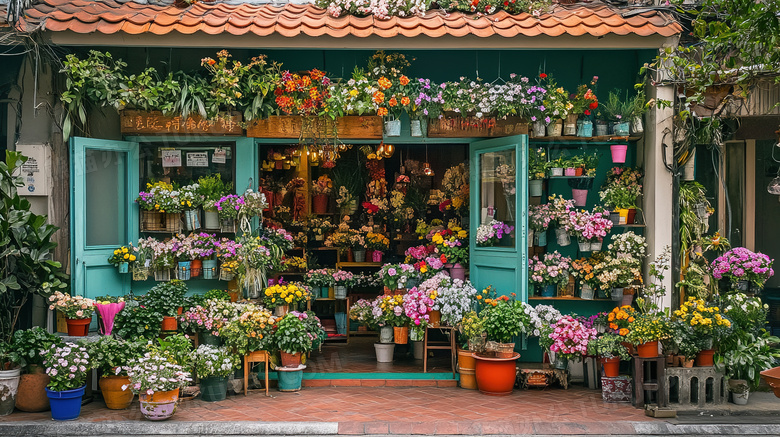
44,343,91,420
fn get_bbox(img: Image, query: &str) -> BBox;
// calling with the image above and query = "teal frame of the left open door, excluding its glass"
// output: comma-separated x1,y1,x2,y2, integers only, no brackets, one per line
70,137,139,298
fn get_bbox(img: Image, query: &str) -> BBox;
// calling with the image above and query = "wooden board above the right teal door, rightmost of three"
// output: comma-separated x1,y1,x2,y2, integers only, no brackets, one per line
428,115,528,138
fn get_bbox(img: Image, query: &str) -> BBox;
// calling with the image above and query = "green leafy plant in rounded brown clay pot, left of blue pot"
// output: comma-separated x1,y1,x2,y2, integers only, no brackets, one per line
11,326,63,413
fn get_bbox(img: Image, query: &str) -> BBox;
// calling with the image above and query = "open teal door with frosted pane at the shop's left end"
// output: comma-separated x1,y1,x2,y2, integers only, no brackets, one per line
70,137,139,298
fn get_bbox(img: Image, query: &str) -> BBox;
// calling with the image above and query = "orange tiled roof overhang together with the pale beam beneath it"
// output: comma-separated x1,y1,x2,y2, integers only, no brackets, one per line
15,0,682,49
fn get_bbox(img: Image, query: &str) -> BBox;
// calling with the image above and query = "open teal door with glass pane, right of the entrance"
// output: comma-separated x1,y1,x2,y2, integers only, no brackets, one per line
469,135,528,301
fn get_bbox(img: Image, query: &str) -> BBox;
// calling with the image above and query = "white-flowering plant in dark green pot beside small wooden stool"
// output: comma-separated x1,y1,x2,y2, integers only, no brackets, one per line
192,344,239,402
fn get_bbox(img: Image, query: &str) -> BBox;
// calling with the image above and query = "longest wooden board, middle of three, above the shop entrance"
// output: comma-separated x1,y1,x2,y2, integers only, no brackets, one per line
246,115,383,140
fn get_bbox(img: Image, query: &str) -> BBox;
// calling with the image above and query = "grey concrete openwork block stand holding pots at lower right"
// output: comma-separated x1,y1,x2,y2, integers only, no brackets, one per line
666,367,726,408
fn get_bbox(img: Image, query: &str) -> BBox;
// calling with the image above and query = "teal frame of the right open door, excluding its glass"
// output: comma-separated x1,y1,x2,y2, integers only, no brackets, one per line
469,135,528,302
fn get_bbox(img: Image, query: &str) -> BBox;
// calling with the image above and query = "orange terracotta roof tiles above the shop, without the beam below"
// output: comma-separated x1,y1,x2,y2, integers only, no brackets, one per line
18,0,682,38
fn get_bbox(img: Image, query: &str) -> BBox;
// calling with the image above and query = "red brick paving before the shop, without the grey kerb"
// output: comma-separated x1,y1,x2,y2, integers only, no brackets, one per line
0,386,654,434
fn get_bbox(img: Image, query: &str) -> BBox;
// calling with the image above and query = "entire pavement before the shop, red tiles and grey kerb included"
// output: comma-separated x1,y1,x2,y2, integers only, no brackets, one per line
0,386,780,436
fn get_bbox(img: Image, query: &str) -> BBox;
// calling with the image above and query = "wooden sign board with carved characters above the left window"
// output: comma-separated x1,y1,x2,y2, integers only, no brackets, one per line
119,110,244,135
